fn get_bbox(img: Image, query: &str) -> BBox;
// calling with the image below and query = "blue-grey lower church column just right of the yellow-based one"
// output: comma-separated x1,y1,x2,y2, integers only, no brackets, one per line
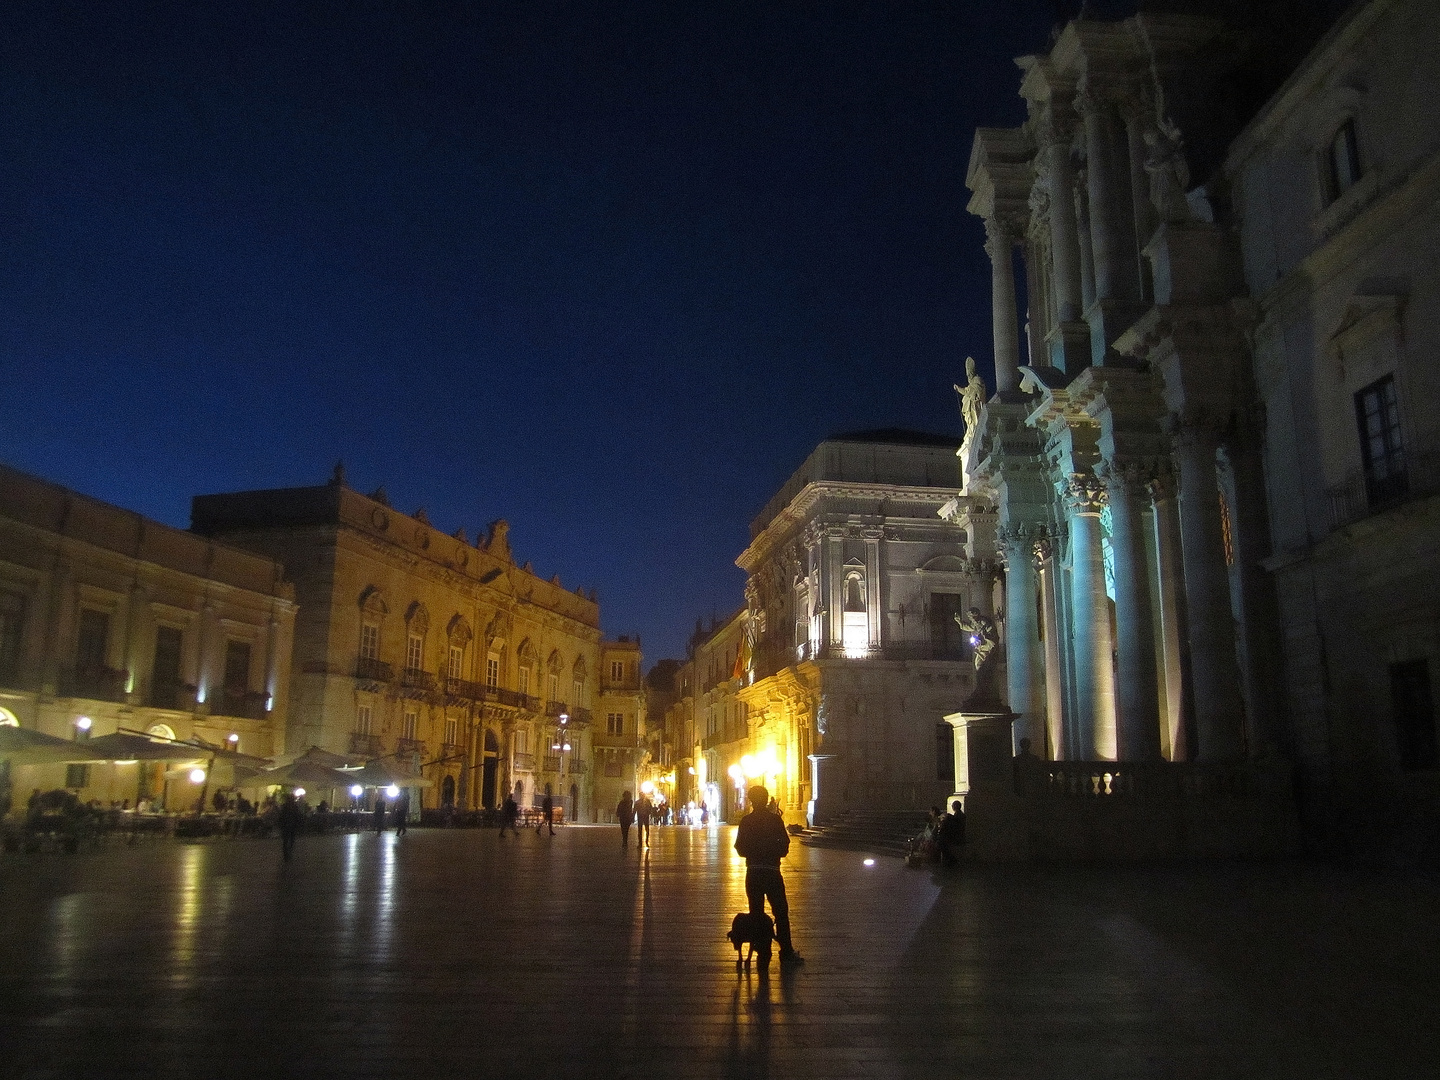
1106,464,1161,762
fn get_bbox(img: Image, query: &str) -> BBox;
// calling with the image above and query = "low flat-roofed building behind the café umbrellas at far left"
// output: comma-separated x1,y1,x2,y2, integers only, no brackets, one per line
0,465,295,809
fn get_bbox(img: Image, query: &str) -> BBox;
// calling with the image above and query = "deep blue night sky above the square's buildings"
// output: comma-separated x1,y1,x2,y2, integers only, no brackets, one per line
0,0,1054,661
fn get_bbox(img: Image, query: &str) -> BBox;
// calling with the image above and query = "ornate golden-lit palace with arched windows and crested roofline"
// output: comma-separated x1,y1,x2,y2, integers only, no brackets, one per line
192,468,600,821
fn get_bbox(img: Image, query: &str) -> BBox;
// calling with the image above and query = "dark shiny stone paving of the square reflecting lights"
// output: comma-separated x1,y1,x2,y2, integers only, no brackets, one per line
0,827,1440,1080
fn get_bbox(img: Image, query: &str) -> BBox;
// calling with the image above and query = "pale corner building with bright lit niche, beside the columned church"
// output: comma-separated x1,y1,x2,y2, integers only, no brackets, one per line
737,431,996,821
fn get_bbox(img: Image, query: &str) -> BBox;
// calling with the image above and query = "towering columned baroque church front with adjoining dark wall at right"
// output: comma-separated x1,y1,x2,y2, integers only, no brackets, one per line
962,0,1440,852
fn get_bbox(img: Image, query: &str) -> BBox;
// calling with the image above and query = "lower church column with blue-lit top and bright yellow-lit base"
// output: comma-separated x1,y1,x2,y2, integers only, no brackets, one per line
1063,472,1117,762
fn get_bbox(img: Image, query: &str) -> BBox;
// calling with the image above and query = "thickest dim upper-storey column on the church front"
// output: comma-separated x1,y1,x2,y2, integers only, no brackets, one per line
1076,89,1140,300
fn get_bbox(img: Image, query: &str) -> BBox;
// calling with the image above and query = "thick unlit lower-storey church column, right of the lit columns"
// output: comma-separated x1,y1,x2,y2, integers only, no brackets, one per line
1175,420,1244,762
